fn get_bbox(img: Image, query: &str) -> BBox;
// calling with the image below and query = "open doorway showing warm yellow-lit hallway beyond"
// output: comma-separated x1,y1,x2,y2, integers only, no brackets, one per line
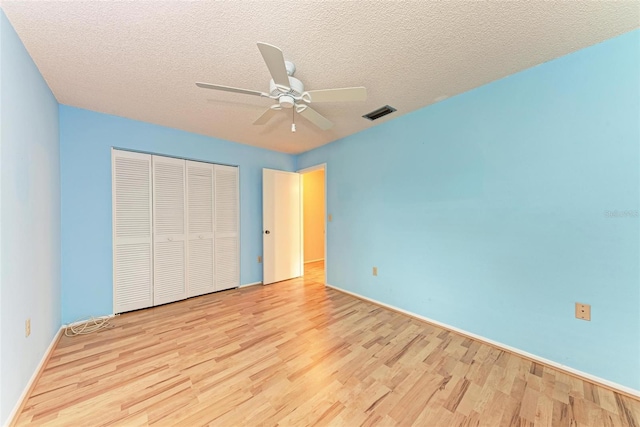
300,165,327,283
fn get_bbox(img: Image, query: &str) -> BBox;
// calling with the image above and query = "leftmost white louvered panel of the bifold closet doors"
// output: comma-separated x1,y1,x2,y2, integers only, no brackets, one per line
111,150,153,313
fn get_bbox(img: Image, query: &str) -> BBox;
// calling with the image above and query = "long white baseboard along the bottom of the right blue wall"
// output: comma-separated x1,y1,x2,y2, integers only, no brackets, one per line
325,283,640,397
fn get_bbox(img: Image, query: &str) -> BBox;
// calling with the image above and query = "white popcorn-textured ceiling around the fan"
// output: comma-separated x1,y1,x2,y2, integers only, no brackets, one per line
1,1,640,153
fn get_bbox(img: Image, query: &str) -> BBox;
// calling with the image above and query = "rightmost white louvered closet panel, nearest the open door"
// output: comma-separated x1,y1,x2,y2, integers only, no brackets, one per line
214,165,240,291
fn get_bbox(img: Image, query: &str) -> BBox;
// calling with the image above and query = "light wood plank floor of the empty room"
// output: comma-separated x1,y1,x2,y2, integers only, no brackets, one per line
13,263,640,427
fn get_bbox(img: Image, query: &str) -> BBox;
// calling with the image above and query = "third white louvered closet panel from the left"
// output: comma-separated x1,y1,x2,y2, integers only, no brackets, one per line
187,161,215,297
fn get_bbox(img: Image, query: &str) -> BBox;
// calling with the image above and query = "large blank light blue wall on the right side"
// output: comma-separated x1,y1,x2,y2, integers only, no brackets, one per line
297,31,640,390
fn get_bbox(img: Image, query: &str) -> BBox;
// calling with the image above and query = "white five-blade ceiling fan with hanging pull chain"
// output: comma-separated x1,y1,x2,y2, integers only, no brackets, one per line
196,43,367,132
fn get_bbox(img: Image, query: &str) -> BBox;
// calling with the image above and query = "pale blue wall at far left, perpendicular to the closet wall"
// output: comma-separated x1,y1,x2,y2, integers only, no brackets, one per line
0,11,60,424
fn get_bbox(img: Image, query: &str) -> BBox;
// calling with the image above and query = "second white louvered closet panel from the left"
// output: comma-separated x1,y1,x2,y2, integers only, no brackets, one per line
153,156,187,305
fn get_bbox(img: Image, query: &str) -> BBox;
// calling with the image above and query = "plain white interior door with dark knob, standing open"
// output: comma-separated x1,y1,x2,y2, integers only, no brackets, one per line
262,169,303,285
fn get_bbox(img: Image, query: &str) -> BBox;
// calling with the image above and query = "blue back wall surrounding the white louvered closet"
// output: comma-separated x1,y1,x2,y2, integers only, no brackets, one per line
60,105,294,323
